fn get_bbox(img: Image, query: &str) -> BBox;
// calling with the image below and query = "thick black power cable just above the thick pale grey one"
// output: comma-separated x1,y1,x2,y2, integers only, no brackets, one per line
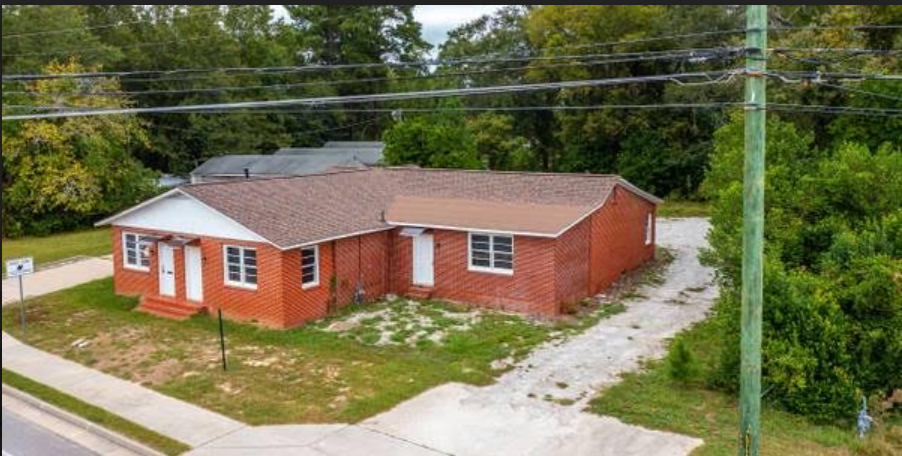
3,48,741,97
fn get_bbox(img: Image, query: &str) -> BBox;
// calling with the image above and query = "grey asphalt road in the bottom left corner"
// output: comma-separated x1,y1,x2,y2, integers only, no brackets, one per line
3,407,97,456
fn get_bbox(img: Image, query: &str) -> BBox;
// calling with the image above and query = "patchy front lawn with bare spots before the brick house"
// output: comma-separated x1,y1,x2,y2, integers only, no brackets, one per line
3,279,588,424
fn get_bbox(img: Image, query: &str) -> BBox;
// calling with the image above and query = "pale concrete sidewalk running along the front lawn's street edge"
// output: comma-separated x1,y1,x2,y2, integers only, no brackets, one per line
3,332,445,456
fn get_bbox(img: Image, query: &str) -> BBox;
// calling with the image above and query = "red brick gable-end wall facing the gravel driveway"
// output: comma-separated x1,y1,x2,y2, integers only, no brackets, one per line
589,186,655,295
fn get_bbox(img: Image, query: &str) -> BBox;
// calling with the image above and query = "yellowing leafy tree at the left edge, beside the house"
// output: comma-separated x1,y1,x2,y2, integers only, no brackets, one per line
3,63,155,236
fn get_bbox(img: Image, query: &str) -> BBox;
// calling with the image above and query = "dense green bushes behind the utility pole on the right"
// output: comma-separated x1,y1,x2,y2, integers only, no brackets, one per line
703,116,902,419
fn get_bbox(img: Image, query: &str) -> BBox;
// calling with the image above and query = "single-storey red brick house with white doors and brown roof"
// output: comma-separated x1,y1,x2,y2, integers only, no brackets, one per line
98,168,661,328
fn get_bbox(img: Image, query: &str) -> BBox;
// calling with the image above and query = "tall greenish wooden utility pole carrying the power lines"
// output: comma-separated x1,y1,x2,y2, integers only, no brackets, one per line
739,5,767,456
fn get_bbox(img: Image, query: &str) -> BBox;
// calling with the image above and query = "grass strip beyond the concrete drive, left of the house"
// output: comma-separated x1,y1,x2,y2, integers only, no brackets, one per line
3,228,113,273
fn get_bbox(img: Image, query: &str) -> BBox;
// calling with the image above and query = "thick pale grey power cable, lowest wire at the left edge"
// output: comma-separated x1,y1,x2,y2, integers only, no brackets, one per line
3,70,740,121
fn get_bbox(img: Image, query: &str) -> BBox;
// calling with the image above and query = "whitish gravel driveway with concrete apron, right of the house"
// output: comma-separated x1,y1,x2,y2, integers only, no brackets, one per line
362,218,717,456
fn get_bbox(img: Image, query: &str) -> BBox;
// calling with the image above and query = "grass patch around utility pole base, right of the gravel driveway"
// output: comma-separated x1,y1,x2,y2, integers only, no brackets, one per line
591,320,902,456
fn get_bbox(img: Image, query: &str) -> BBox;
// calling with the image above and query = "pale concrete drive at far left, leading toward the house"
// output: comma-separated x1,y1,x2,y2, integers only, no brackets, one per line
3,256,113,306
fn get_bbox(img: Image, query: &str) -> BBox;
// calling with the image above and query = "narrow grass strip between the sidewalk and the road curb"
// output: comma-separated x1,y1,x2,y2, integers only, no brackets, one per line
3,369,191,455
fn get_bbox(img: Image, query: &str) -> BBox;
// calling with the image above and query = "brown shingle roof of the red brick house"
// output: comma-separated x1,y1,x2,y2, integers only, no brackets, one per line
181,168,657,248
